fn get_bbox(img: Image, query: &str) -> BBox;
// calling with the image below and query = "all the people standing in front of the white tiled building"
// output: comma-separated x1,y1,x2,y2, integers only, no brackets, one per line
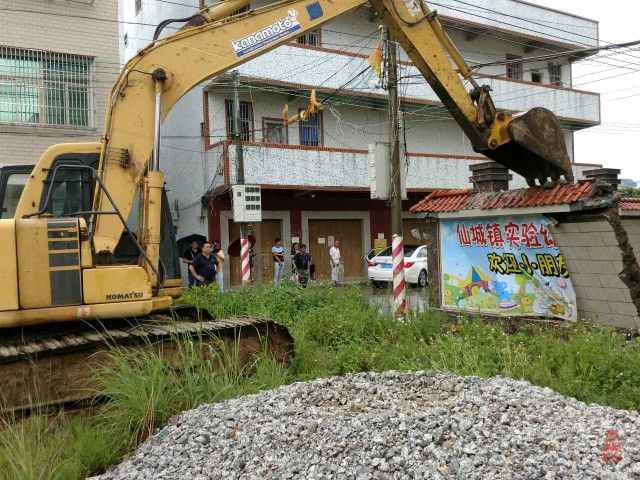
182,238,342,291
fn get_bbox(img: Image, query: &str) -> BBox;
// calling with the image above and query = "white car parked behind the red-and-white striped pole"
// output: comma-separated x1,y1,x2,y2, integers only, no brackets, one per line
365,245,427,288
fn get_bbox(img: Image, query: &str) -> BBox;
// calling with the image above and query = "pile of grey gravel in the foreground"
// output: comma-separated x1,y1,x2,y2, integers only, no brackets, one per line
97,371,640,480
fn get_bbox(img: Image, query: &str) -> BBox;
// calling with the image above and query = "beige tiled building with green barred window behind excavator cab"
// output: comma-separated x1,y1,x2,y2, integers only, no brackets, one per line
0,0,122,166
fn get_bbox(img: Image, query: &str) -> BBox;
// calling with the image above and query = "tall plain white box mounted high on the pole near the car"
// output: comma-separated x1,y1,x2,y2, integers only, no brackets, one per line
367,142,407,200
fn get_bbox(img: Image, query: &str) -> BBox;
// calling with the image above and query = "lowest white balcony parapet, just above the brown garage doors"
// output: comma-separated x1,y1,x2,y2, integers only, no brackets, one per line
212,141,597,192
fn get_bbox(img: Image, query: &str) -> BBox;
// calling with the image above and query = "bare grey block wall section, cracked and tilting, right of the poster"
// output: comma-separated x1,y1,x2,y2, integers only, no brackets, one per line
552,221,640,329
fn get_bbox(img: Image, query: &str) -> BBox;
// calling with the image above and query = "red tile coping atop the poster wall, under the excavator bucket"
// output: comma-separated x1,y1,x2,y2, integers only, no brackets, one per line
411,180,600,213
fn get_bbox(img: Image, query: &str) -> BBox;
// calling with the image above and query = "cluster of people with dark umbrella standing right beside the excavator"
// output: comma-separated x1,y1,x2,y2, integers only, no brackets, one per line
182,240,225,291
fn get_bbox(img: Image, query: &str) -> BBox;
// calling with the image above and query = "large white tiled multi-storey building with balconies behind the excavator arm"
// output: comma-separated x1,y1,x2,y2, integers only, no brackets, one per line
124,0,600,282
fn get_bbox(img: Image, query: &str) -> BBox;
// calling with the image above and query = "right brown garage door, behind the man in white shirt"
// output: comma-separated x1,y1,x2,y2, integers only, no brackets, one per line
307,220,364,280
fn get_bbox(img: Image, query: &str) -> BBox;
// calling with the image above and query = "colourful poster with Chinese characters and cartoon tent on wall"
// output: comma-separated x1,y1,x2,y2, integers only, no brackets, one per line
440,215,577,321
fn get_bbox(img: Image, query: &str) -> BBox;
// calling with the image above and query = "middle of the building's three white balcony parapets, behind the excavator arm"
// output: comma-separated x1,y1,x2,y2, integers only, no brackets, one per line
214,44,600,130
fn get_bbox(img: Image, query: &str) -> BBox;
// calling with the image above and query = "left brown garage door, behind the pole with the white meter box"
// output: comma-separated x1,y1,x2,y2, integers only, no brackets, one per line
229,220,282,285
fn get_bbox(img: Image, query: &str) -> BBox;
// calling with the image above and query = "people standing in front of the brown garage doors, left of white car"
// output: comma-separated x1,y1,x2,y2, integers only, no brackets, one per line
271,238,342,287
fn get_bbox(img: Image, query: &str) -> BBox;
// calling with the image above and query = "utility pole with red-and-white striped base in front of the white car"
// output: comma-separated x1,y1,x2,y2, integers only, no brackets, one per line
387,28,406,317
